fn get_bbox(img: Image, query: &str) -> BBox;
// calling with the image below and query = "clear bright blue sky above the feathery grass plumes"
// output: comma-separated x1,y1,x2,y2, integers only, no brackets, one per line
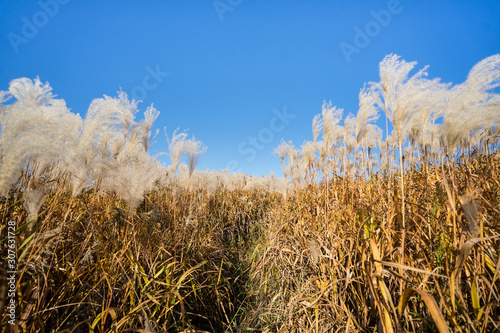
0,0,500,175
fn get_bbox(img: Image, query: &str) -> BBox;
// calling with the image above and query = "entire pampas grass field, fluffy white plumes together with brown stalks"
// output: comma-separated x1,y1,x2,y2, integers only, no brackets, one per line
0,55,500,332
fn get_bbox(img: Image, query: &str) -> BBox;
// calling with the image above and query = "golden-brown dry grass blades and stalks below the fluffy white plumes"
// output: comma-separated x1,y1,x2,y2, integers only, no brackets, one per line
0,152,500,332
